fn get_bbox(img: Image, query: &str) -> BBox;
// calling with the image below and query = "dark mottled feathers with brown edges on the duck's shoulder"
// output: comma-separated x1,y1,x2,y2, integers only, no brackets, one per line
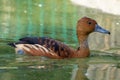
39,38,73,57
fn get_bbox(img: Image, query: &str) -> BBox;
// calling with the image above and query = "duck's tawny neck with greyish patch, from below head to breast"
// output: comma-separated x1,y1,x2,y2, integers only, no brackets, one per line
76,35,90,57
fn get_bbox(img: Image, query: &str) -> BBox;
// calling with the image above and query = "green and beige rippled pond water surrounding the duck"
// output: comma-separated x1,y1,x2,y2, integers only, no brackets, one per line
0,0,120,80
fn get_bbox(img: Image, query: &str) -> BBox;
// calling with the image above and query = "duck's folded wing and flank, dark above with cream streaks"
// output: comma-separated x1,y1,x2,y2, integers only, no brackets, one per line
9,37,74,58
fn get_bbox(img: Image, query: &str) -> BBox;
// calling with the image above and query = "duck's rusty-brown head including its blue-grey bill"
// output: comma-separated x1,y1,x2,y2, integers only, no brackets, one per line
77,17,110,38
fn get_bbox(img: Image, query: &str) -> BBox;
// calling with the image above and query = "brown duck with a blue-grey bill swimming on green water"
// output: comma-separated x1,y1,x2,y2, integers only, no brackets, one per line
8,17,110,59
